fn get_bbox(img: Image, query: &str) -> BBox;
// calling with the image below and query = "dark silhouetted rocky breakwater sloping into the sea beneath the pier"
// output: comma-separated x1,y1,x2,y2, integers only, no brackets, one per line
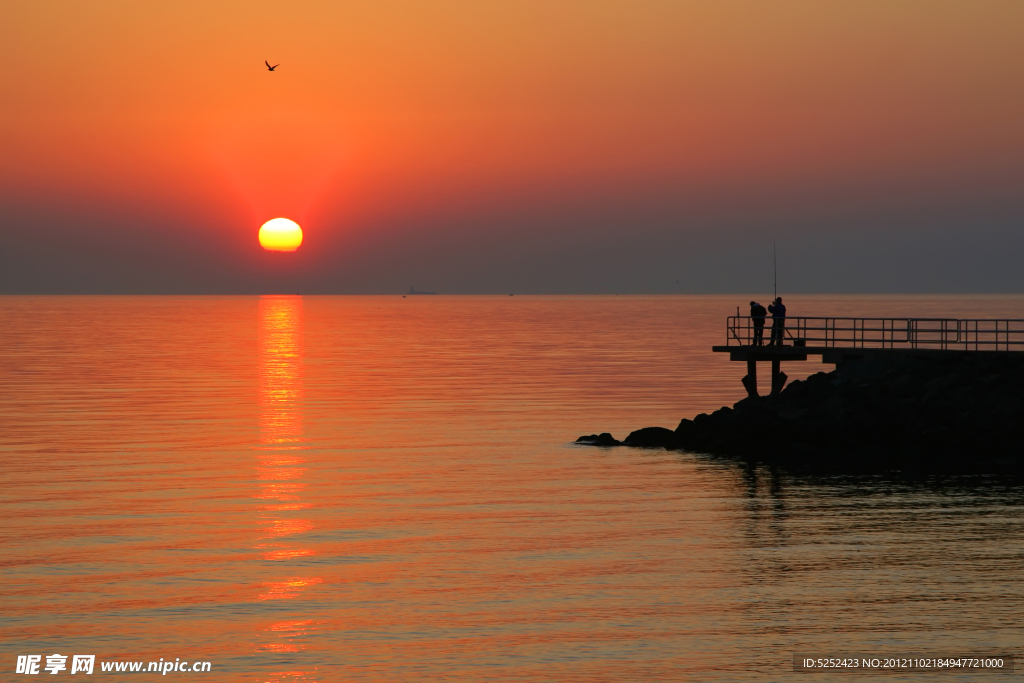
577,352,1024,473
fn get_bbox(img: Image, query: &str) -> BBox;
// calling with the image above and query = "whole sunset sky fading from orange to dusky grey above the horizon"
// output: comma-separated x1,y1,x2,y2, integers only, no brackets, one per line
0,0,1024,294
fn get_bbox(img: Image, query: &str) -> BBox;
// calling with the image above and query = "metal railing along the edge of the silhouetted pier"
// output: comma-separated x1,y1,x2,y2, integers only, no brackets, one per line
726,315,1024,351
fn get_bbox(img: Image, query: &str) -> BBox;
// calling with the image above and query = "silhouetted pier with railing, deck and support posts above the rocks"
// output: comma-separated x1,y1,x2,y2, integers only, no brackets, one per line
712,315,1024,396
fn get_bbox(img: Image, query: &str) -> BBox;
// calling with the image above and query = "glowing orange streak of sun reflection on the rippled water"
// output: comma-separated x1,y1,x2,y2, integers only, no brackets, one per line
255,296,323,680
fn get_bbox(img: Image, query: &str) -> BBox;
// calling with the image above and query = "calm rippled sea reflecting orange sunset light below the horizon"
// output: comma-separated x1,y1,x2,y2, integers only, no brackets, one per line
0,297,1024,682
